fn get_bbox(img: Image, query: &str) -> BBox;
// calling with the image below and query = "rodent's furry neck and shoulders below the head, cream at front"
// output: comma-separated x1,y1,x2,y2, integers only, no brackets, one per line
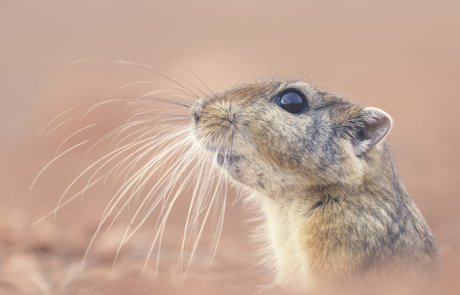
255,147,436,289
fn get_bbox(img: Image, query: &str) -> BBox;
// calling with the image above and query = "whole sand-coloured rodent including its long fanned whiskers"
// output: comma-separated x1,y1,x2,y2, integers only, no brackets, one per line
34,76,438,290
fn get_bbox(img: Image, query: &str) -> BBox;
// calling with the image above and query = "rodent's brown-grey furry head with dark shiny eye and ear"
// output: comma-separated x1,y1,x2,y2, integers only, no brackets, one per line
192,81,392,196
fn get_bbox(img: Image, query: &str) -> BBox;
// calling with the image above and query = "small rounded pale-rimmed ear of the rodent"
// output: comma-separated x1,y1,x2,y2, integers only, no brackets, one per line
342,107,393,156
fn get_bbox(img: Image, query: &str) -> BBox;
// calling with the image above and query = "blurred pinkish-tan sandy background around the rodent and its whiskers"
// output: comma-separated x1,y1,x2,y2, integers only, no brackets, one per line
0,0,460,294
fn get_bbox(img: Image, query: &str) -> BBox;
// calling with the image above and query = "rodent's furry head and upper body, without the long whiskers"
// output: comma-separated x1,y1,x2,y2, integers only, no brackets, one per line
192,81,437,289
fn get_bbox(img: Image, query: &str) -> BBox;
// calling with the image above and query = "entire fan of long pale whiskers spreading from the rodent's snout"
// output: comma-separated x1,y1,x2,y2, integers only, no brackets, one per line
37,70,237,281
